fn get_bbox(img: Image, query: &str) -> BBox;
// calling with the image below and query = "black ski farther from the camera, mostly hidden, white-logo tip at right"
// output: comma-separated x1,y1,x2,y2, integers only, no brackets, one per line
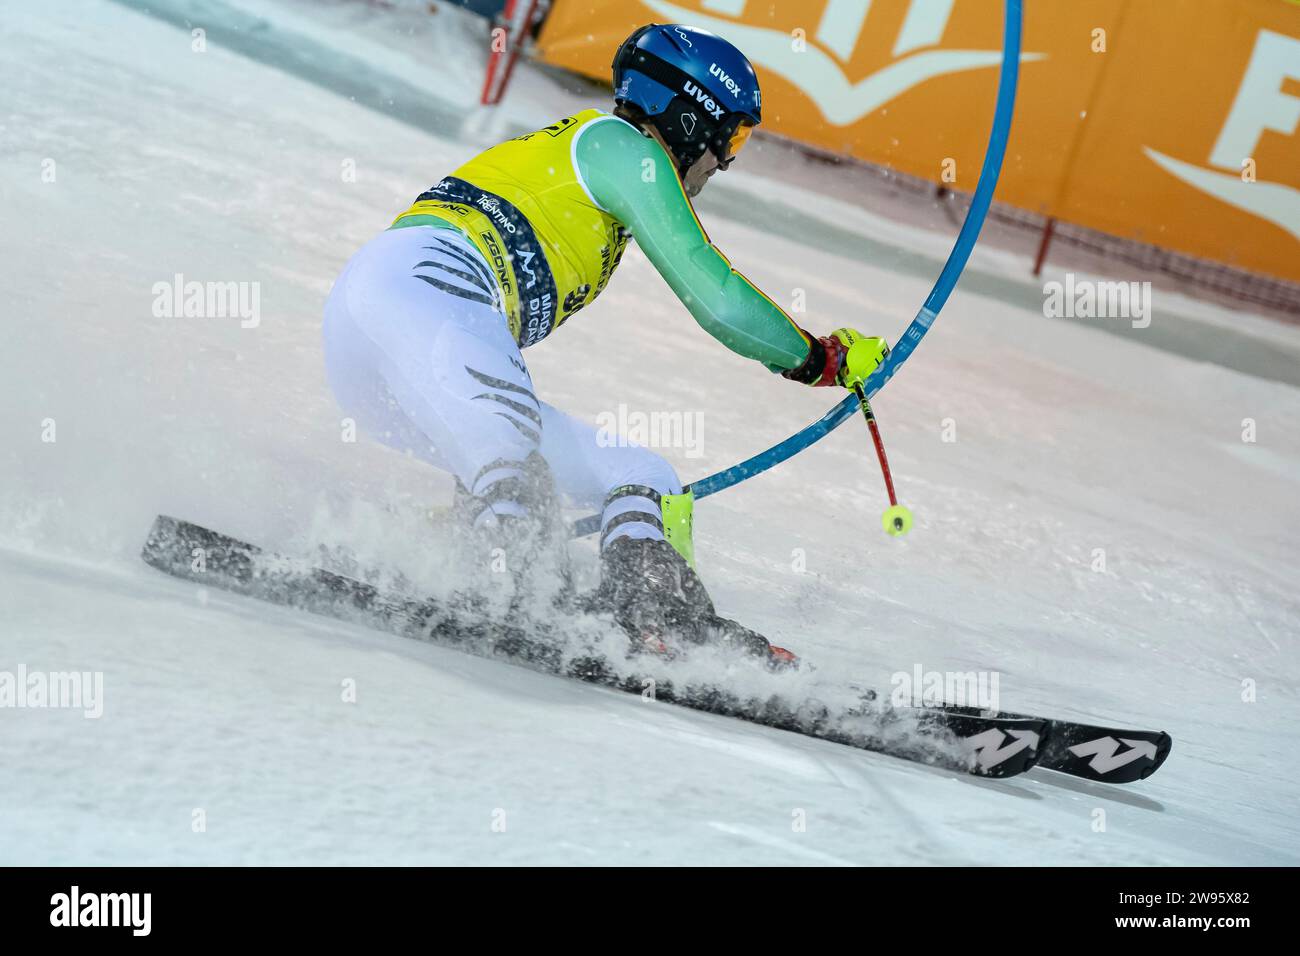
943,706,1174,783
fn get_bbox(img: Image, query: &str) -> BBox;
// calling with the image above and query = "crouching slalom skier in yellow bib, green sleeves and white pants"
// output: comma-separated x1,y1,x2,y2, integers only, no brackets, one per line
324,25,888,659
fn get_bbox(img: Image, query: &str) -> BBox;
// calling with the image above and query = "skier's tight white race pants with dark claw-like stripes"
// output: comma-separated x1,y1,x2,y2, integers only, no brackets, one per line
324,226,681,545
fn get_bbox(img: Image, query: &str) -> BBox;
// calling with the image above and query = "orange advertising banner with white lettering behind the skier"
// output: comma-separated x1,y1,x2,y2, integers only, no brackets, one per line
540,0,1300,282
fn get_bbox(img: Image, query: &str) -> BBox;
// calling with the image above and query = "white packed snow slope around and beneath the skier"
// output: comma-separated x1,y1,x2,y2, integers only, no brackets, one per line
0,0,1300,864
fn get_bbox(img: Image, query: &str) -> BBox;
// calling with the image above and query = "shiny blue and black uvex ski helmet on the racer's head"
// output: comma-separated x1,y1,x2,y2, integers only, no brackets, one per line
614,23,762,173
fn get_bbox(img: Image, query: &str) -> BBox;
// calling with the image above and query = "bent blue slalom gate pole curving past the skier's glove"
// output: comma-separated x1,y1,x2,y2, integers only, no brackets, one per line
573,0,1023,537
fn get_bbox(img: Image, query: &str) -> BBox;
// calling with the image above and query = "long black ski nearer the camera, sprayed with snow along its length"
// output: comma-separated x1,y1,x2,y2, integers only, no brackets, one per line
142,515,1047,777
